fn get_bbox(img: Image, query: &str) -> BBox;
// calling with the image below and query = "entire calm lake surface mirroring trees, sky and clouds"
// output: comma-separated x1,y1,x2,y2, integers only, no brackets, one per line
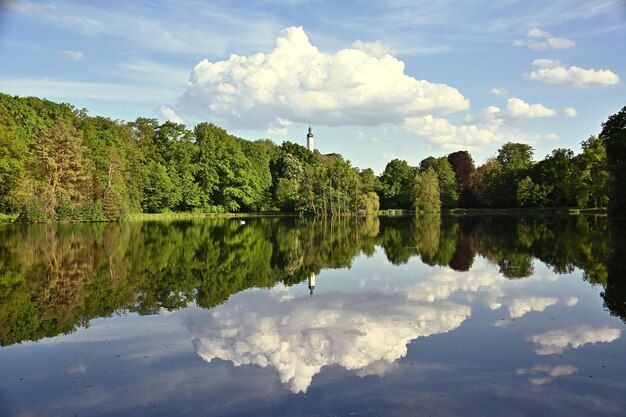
0,217,626,416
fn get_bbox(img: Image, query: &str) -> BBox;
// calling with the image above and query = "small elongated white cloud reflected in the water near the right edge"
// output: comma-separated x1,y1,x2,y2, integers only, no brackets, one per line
530,325,622,355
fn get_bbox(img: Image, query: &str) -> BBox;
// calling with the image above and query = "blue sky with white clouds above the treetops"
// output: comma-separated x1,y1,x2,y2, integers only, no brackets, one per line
0,0,626,173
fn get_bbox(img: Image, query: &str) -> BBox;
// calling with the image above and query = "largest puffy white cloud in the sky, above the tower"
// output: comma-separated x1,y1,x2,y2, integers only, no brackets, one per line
181,27,469,128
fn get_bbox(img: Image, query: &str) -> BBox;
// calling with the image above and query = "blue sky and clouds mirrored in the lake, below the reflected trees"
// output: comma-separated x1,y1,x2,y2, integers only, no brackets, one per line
0,251,626,416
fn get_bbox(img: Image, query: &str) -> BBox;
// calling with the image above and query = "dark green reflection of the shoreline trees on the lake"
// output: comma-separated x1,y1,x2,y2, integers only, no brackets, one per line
0,216,626,346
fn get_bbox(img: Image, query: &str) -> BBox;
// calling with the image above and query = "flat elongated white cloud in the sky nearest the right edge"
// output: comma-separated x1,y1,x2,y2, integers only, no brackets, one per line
526,59,620,88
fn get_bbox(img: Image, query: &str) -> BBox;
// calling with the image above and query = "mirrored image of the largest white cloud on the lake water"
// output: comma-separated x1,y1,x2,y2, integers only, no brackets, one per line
181,292,471,393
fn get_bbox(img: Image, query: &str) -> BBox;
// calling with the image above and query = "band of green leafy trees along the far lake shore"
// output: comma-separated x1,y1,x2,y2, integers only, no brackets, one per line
0,93,626,222
